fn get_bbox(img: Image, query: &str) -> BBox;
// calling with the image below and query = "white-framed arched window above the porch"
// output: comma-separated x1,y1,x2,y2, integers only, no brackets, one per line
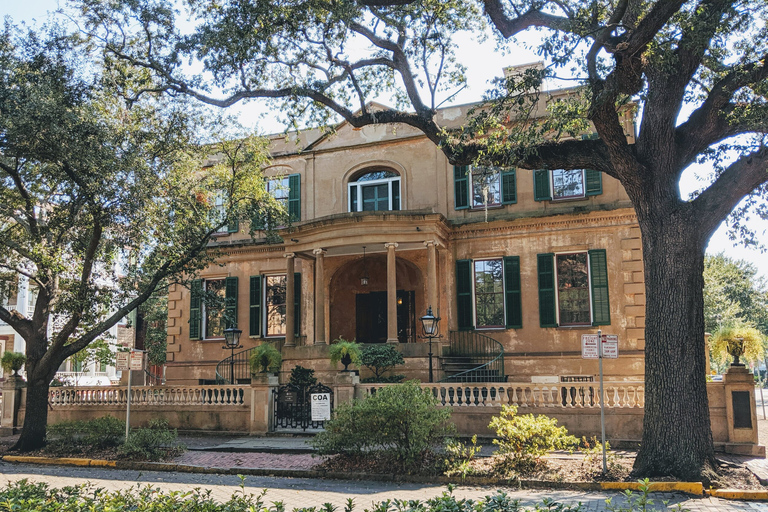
347,169,400,212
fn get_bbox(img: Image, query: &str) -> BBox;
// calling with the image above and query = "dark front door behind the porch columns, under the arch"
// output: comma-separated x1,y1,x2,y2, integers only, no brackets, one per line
355,290,416,343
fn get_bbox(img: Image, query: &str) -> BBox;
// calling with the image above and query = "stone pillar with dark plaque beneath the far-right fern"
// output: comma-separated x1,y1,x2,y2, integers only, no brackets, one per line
723,366,765,457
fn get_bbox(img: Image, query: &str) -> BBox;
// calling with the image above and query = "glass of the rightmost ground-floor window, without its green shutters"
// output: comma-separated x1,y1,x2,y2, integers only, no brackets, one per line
557,252,592,325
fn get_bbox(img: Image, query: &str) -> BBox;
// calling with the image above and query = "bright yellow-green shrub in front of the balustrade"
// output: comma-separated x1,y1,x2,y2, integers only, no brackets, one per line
488,405,578,473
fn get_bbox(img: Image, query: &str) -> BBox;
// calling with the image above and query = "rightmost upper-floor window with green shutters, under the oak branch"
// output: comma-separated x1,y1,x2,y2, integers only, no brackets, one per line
533,169,603,201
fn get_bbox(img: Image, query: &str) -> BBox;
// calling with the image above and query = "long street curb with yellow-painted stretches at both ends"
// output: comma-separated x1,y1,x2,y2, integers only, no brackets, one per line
2,455,708,500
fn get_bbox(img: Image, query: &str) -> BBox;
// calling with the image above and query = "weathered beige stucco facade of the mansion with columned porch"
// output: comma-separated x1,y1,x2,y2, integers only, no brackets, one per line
166,96,645,384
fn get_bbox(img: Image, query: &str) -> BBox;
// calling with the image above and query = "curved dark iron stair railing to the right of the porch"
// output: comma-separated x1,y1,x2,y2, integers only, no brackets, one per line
439,331,507,382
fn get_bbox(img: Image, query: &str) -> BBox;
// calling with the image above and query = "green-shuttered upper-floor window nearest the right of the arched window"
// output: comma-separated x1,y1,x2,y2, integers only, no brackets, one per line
453,165,517,210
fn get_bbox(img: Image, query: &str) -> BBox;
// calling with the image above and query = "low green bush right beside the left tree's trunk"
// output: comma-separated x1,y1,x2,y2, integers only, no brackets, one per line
46,416,125,453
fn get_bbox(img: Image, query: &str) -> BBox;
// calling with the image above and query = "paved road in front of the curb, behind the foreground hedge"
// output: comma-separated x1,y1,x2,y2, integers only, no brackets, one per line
0,462,768,512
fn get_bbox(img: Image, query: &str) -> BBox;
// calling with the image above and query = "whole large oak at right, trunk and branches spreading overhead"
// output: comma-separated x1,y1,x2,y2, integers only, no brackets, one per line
73,0,768,479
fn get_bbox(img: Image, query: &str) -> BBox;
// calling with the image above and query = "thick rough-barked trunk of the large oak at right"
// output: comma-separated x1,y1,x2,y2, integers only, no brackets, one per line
633,205,716,482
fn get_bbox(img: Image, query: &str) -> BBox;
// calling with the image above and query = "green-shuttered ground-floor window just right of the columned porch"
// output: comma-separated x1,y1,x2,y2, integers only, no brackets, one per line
456,256,523,330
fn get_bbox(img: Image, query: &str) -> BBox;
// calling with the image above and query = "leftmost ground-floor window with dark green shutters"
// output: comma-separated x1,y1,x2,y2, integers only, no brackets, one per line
189,277,238,340
